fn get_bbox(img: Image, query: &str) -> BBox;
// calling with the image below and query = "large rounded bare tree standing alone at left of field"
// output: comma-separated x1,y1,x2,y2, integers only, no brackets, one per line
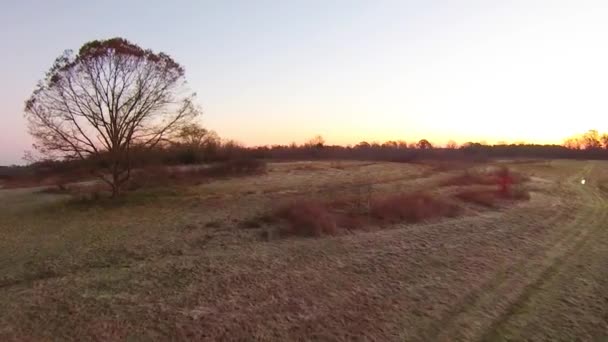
25,38,199,196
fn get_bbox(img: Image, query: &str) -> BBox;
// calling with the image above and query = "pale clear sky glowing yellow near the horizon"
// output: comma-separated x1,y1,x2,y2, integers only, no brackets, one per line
0,0,608,165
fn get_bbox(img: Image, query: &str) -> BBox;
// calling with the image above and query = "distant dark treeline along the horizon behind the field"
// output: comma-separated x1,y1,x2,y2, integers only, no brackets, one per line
0,127,608,180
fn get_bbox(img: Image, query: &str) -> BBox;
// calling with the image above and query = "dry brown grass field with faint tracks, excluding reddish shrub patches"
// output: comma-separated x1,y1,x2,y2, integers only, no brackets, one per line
0,160,608,341
